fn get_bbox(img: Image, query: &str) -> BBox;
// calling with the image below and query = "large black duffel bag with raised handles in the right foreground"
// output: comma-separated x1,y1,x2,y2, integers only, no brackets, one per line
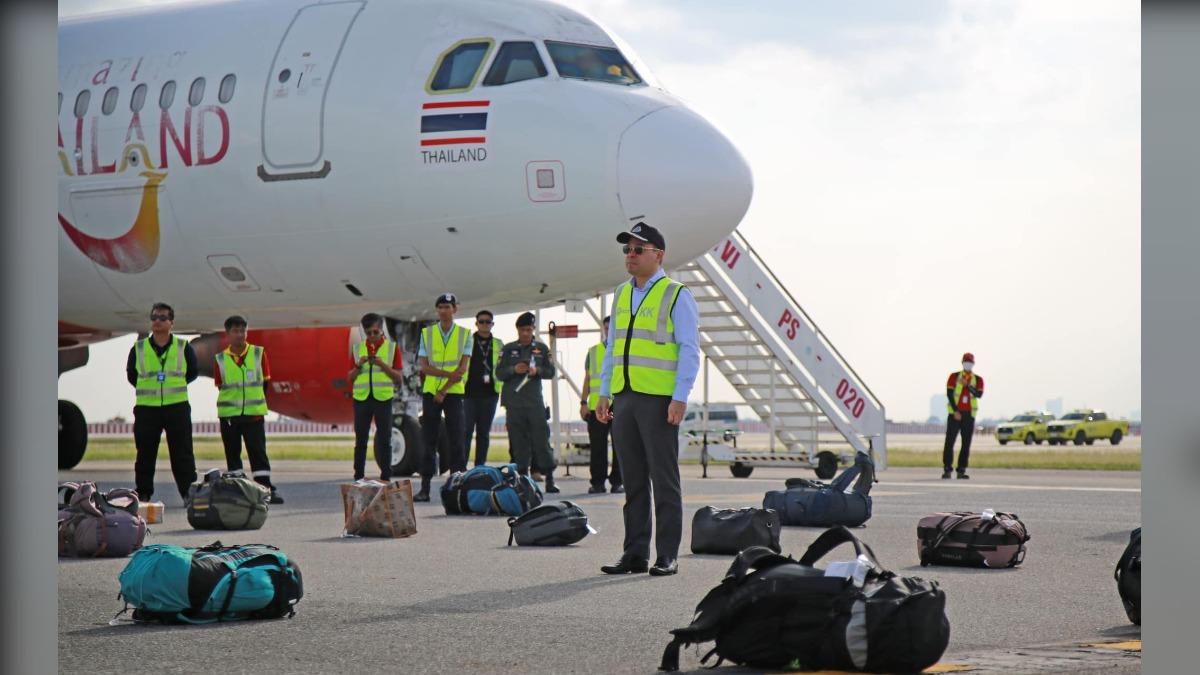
659,526,950,673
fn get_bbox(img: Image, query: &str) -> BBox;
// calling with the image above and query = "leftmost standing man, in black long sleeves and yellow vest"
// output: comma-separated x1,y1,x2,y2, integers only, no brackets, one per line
125,303,199,502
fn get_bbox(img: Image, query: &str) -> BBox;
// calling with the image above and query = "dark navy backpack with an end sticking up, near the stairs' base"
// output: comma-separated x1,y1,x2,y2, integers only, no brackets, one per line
762,453,875,527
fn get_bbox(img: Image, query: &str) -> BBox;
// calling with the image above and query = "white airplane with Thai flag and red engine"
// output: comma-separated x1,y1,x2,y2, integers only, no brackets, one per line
56,0,752,476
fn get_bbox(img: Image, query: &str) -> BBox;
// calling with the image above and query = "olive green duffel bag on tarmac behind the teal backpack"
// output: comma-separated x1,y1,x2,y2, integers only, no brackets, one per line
187,468,271,530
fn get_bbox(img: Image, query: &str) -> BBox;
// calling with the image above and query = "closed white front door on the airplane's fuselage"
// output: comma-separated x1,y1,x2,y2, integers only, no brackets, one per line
258,0,366,180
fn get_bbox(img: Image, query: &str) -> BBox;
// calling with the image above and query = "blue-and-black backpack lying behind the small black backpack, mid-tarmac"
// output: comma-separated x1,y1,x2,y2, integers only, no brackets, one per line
442,464,542,515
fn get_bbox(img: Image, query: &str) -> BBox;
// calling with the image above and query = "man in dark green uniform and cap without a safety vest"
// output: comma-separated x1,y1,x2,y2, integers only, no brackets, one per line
496,312,559,492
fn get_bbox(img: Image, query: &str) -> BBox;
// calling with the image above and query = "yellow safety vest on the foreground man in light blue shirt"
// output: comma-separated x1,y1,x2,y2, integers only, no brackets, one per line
612,276,683,396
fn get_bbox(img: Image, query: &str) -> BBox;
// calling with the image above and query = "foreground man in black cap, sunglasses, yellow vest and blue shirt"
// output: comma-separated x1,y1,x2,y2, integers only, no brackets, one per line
595,222,700,577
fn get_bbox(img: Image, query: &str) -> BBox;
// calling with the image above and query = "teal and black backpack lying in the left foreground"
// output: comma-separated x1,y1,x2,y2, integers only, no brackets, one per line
119,542,304,623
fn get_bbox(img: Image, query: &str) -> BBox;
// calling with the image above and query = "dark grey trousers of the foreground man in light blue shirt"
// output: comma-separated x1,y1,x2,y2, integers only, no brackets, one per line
612,390,683,558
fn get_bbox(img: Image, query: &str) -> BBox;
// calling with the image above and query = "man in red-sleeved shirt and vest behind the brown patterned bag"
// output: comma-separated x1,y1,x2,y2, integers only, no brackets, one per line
346,312,403,482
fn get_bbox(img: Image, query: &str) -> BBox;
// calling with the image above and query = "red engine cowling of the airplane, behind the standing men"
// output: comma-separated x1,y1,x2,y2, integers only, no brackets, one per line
192,325,359,424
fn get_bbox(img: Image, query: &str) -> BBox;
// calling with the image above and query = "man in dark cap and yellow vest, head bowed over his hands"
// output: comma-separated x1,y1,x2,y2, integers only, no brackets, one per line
413,293,472,502
